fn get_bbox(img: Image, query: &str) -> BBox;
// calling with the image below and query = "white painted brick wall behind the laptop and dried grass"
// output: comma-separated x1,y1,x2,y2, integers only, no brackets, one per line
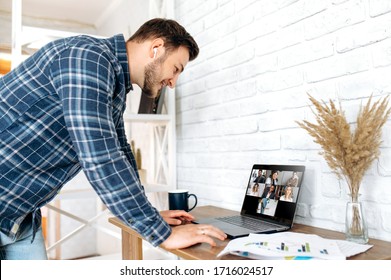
175,0,391,241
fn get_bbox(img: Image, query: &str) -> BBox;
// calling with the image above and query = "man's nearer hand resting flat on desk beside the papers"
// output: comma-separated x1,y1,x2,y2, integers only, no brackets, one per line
161,224,227,249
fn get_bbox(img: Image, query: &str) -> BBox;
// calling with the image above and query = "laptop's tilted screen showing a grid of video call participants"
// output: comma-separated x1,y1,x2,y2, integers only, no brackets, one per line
241,164,305,225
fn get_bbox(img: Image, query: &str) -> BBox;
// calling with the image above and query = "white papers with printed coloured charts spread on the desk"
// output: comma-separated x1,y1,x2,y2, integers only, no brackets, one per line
218,232,372,260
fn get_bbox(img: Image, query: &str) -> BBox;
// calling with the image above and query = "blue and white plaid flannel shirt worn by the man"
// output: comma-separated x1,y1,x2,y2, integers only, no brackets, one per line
0,35,171,246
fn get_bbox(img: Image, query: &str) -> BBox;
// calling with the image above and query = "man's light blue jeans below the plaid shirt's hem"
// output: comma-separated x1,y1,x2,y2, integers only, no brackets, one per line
0,219,47,260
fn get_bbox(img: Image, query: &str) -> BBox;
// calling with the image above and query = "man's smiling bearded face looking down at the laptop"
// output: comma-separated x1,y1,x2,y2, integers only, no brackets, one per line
142,46,189,98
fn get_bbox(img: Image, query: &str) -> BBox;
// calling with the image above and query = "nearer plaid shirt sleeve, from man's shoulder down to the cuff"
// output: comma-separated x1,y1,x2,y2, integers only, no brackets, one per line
51,43,171,246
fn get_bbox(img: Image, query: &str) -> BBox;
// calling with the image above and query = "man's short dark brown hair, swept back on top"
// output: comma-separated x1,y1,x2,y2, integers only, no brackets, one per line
128,18,200,61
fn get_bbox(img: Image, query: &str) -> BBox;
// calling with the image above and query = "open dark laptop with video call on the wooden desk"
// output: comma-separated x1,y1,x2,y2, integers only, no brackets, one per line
195,164,305,238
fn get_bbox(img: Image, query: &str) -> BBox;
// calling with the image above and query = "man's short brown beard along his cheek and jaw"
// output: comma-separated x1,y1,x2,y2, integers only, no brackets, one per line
141,55,166,98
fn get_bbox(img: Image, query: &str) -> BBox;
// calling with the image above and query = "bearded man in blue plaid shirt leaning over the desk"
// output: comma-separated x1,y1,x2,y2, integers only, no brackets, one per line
0,19,226,259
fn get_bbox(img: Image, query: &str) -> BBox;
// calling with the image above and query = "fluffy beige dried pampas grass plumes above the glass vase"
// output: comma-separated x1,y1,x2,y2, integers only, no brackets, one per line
297,95,391,202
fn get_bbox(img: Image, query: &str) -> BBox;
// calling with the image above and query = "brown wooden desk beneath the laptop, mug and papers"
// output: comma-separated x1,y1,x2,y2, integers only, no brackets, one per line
109,206,391,260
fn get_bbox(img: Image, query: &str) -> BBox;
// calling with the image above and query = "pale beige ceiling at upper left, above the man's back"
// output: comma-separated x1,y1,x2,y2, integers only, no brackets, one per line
0,0,124,27
